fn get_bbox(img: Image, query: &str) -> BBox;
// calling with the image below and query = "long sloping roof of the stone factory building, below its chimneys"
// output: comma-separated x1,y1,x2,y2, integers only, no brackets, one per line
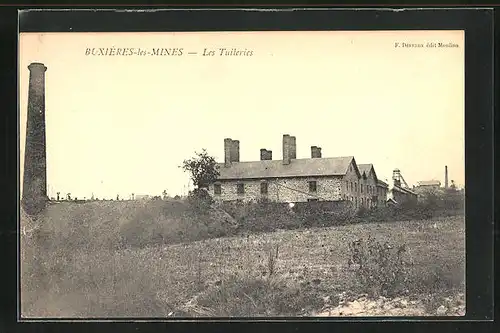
218,156,354,180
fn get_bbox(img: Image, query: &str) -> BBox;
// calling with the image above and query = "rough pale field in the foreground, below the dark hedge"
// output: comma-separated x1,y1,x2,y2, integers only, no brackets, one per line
22,213,465,317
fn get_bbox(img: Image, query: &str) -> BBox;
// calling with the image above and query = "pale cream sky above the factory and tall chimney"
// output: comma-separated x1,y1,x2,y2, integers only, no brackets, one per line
19,31,465,198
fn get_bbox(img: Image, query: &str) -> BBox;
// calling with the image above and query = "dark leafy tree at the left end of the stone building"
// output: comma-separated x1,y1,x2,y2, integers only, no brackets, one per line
181,149,219,189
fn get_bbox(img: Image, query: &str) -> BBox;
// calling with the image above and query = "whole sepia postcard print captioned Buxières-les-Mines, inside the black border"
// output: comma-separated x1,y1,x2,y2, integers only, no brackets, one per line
18,30,466,319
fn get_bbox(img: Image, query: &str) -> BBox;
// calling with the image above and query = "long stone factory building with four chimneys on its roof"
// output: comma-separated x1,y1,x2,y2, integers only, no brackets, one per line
208,134,387,208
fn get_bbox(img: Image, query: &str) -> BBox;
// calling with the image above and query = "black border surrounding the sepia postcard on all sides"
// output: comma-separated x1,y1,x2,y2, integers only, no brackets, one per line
0,7,495,331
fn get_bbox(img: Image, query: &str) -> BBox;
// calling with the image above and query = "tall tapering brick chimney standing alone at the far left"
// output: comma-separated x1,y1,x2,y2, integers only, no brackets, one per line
22,63,48,215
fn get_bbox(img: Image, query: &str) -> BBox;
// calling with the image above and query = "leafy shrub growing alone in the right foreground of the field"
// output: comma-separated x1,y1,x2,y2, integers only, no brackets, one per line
348,236,409,297
